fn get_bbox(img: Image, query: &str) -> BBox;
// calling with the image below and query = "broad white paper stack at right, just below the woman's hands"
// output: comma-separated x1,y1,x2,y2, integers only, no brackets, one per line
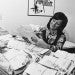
38,50,75,72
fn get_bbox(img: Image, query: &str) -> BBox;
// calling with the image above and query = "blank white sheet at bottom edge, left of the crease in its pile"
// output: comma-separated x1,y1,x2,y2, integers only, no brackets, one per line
25,62,47,75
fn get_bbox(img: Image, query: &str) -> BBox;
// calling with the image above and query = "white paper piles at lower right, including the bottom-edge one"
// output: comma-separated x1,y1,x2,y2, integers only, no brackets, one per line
23,50,75,75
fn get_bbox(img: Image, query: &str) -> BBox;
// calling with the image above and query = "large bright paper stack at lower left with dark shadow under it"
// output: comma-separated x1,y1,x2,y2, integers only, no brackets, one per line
3,49,30,70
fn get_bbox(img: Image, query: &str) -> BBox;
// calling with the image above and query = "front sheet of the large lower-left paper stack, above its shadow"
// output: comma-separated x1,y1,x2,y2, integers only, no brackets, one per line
9,55,29,70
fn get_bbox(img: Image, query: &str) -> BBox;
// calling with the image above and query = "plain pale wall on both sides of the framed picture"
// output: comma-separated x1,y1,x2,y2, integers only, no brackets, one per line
0,0,75,42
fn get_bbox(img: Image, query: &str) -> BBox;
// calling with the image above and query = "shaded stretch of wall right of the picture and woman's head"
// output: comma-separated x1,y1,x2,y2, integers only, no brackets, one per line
55,0,75,42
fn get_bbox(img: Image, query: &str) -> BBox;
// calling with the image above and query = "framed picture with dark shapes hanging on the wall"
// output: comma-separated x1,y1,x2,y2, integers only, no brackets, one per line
28,0,55,16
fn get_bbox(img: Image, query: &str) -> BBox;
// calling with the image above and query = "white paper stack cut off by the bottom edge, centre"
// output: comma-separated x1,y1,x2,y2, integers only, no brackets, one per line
23,62,57,75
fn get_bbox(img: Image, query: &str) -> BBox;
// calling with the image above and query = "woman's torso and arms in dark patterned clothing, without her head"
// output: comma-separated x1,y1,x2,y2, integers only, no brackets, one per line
37,28,66,51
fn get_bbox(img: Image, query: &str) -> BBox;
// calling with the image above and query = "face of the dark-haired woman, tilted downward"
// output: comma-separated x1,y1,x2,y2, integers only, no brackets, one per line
50,19,62,30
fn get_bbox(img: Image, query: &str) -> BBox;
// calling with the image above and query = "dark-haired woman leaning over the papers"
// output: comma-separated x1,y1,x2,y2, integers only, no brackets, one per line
33,12,68,52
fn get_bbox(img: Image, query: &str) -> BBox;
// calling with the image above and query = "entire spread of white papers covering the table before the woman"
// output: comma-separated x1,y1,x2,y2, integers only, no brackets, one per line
0,26,75,75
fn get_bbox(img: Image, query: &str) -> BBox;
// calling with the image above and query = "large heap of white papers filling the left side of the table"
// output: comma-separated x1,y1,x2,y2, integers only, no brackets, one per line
0,34,48,74
